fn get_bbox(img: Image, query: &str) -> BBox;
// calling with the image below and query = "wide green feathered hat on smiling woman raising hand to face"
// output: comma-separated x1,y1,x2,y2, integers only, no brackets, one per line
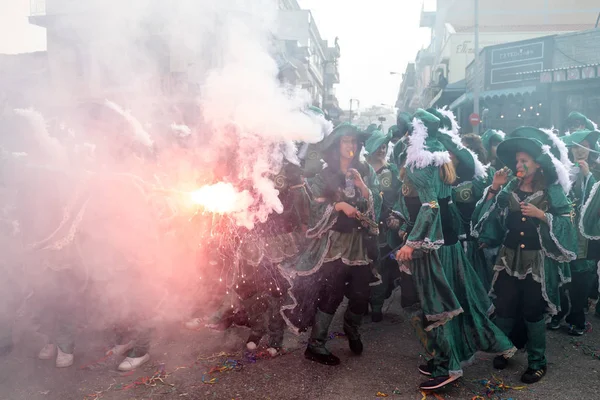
496,127,573,193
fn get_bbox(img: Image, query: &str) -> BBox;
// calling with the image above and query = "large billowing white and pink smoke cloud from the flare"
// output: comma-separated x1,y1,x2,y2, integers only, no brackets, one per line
0,0,331,340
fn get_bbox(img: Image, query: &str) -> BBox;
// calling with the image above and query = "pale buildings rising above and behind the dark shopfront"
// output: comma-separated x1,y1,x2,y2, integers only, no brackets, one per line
398,0,600,115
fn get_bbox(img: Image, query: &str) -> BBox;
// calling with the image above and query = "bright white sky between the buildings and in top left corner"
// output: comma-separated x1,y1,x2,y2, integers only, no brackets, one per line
0,0,431,109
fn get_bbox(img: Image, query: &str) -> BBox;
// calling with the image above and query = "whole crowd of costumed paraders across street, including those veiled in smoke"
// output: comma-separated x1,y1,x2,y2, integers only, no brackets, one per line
0,102,600,390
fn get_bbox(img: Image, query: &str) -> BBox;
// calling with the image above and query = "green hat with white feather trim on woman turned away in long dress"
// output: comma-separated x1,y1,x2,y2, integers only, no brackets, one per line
406,109,450,168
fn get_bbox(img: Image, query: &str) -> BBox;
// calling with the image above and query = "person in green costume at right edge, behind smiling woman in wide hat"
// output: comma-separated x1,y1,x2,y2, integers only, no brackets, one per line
549,130,600,336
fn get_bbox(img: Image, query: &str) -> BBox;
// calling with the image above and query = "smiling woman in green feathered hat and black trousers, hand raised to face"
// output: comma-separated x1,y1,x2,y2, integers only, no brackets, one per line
474,127,577,384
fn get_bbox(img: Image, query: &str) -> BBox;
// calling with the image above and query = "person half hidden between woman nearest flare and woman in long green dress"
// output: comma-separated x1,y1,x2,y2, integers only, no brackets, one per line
365,130,400,322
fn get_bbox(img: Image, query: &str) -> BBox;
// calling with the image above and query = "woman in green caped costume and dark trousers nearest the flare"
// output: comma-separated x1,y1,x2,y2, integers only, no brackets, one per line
281,123,381,365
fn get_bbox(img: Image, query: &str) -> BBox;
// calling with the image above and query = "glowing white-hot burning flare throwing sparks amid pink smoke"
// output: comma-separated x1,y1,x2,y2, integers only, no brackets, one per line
190,182,253,214
